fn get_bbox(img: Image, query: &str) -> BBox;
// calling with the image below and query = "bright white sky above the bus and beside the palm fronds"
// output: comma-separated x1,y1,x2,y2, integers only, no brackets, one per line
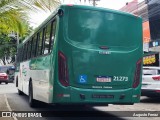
30,0,144,28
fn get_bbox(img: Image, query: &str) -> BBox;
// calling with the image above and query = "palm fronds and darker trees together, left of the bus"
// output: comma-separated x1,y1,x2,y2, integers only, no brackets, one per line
0,0,60,65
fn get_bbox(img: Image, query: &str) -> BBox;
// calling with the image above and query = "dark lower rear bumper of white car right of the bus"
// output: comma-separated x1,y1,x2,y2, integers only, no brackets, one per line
141,89,160,96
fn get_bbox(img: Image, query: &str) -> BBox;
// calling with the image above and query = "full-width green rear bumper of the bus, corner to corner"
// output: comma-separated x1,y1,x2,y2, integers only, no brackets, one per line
53,87,140,105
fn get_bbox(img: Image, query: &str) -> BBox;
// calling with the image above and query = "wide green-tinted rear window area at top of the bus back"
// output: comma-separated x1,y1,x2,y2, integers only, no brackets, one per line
65,8,142,47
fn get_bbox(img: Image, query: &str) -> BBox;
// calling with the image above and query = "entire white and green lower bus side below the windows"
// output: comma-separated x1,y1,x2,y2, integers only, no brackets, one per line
15,56,53,103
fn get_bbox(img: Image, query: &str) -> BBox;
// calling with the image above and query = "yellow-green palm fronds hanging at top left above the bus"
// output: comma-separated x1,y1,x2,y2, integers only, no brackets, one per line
0,0,60,35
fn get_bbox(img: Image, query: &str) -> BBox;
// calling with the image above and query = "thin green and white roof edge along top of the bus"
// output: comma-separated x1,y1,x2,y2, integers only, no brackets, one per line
18,4,140,47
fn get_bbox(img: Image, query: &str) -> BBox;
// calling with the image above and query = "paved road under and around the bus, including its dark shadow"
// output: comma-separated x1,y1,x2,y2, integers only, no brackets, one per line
0,83,160,120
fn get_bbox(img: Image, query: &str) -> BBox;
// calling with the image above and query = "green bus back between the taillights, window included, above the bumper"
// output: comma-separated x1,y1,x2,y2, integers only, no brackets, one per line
65,8,142,89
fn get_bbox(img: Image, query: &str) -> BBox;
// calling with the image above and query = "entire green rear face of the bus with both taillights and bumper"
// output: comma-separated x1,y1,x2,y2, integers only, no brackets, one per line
53,6,142,104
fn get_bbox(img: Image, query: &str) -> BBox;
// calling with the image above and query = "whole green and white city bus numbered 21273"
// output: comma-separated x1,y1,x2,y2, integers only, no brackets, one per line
15,5,143,106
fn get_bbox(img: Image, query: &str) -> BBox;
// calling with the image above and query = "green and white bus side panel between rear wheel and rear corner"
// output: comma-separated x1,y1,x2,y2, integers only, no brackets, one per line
30,55,51,103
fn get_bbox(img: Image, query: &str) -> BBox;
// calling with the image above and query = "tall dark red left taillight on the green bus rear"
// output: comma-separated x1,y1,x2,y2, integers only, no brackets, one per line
58,51,69,87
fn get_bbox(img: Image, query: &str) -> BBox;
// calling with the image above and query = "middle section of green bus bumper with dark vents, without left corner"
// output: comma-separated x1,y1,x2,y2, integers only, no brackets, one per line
71,88,139,104
